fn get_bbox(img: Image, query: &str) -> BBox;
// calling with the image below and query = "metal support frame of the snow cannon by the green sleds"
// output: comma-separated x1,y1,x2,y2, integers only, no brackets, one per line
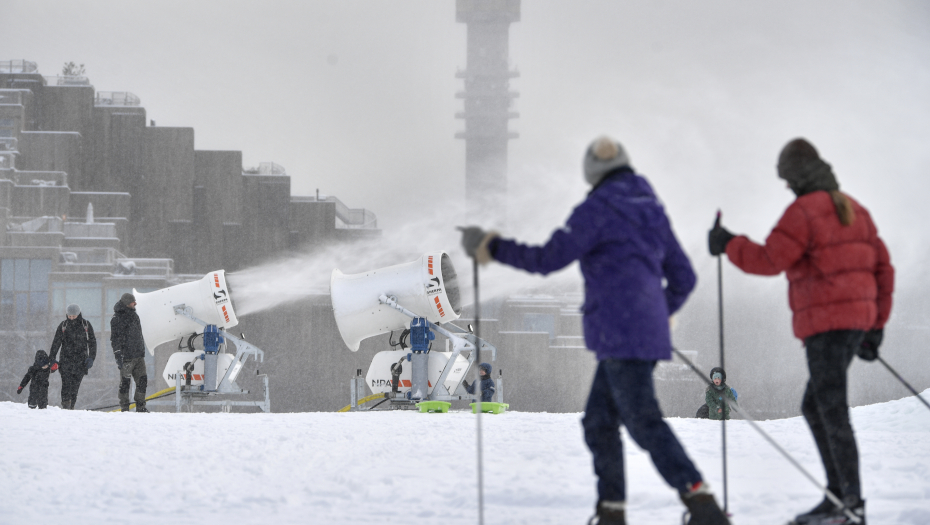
351,294,497,409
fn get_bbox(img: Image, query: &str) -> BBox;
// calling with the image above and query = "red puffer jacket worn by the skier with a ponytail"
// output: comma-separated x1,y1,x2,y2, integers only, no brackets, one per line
727,191,894,340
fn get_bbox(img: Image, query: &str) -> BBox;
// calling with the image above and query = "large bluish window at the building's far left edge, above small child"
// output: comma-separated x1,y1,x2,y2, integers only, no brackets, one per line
0,259,52,332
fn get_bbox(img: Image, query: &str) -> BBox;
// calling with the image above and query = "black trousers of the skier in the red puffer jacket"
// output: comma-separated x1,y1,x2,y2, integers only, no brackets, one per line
801,330,865,499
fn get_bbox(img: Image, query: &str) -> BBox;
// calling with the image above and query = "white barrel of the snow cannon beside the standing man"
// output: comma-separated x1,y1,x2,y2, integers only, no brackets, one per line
132,270,239,354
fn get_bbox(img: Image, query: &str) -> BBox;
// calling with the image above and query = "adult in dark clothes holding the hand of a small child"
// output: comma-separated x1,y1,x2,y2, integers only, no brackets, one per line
48,304,97,410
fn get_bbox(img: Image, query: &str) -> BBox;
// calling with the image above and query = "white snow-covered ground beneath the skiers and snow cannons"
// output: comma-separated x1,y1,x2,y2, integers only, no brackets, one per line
0,390,930,525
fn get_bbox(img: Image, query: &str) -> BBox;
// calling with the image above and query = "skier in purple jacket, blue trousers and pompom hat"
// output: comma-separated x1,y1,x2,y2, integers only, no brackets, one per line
462,137,729,525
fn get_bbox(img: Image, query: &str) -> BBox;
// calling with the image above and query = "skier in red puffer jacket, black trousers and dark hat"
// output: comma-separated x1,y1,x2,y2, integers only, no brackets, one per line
708,138,894,524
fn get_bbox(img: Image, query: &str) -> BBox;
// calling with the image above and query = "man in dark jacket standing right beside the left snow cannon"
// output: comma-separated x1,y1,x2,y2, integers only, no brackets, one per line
110,293,148,412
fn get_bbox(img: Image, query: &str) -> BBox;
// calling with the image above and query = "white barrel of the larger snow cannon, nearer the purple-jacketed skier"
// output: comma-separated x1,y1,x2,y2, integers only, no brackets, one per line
330,251,462,352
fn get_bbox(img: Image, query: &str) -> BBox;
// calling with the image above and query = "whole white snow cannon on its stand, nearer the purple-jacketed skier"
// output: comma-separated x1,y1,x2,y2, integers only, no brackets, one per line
330,251,496,409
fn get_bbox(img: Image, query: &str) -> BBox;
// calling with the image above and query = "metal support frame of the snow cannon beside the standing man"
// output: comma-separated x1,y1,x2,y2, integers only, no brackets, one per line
148,304,271,412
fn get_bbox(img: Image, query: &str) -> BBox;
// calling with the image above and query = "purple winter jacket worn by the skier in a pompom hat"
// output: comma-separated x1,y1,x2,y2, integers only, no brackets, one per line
489,168,696,360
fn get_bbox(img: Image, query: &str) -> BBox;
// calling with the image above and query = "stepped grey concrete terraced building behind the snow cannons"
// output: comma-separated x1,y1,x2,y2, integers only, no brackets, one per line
0,60,380,408
